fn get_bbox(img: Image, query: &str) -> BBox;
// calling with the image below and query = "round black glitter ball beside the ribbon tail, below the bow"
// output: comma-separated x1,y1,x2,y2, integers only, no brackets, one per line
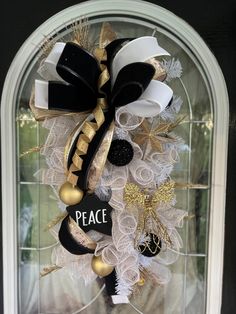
107,139,134,167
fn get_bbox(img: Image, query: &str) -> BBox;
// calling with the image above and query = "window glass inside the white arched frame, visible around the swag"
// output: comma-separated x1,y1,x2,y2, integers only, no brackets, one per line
16,17,213,314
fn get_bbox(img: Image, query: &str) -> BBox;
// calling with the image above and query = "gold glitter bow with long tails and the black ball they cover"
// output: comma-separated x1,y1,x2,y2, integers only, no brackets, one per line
124,180,175,251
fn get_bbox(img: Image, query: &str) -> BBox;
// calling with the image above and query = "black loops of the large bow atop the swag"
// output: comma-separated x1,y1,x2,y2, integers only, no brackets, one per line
48,38,155,112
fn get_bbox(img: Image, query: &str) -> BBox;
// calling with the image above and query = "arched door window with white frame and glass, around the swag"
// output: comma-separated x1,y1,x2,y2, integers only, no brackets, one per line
1,0,228,314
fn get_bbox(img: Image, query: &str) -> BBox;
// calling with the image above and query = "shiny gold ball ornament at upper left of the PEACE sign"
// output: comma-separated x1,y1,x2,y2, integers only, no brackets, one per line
59,181,84,205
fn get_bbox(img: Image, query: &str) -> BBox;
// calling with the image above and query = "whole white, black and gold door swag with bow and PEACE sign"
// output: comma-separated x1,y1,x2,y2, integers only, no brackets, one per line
30,21,186,303
